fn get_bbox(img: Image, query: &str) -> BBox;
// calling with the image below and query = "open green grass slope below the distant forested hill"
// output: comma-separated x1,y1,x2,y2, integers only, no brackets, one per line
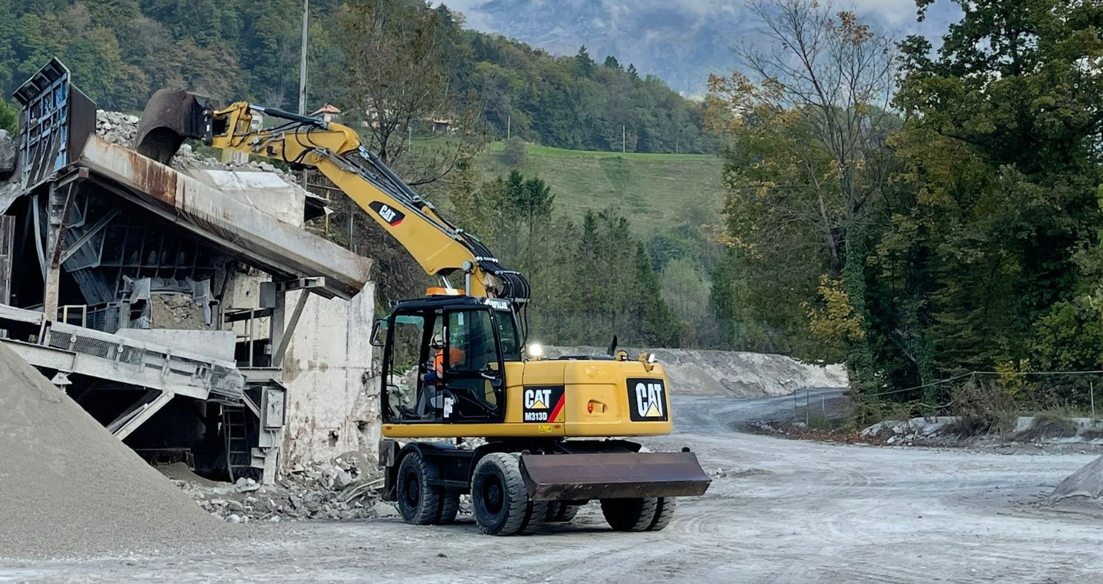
479,142,725,234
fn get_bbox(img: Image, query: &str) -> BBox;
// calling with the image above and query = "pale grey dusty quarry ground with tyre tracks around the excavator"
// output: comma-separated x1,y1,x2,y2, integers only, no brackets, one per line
0,393,1103,584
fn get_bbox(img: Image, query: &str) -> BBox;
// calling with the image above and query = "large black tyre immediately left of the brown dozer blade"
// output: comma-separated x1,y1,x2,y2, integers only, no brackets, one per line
471,453,529,535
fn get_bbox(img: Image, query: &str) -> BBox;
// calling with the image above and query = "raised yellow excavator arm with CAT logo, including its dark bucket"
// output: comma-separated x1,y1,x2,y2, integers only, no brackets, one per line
137,89,529,309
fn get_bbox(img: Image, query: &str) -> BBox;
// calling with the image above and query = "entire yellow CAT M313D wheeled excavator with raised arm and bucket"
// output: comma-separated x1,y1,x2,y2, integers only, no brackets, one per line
136,89,710,535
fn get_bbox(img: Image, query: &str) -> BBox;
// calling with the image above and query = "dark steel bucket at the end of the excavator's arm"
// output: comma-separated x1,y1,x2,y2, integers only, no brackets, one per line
135,89,214,164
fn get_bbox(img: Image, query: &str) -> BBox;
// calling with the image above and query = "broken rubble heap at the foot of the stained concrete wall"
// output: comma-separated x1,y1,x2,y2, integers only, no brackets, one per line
163,455,396,523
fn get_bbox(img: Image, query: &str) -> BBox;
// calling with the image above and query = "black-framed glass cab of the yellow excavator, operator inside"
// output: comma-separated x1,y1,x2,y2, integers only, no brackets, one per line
373,296,521,424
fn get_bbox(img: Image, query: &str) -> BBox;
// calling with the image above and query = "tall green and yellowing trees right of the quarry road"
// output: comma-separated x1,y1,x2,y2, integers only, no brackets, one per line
709,0,1103,419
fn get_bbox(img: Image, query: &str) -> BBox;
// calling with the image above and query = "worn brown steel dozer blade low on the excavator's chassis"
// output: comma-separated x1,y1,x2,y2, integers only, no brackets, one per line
521,453,711,501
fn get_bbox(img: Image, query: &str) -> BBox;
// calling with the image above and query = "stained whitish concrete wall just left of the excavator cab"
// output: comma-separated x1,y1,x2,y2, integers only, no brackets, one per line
280,284,379,469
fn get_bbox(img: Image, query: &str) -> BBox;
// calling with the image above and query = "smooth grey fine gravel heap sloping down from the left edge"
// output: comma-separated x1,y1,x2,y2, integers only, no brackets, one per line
0,344,221,558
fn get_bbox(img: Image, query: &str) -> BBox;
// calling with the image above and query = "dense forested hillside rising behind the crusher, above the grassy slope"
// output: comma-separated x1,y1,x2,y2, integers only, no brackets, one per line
0,0,711,152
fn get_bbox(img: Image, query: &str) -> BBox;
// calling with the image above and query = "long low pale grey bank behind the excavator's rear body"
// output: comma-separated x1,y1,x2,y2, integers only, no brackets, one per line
547,347,847,397
